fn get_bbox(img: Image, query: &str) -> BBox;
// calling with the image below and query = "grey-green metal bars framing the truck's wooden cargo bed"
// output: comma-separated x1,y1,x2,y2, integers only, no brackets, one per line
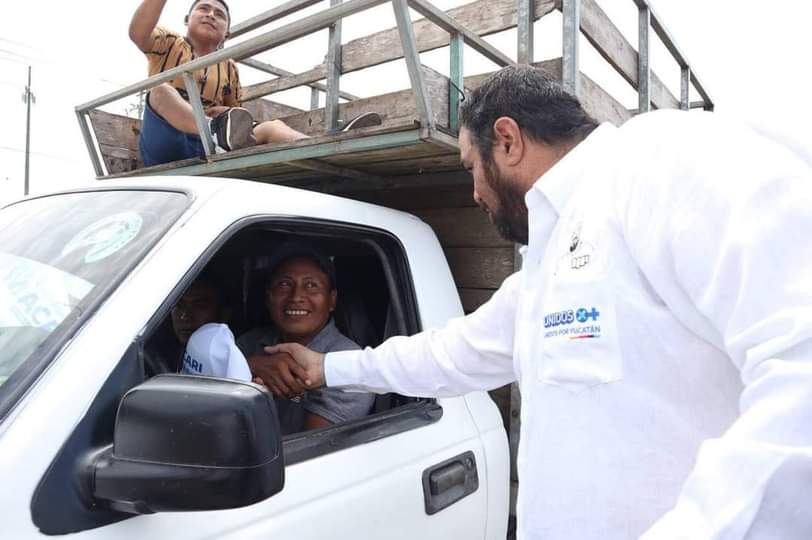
76,0,713,176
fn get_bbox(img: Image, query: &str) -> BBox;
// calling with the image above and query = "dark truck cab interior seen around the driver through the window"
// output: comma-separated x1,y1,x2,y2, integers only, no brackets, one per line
142,219,420,438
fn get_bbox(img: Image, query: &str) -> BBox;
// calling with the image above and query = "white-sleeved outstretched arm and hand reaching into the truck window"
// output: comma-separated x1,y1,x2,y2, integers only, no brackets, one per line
266,273,521,397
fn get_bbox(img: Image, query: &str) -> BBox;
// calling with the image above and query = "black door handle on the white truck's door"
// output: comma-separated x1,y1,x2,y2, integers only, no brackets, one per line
423,451,479,515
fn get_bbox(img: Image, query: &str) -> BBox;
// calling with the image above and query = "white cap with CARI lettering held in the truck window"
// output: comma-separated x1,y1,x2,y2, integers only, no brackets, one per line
181,323,251,381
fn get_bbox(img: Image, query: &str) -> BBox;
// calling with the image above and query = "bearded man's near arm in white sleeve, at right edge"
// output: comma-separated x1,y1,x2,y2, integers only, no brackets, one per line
619,113,812,540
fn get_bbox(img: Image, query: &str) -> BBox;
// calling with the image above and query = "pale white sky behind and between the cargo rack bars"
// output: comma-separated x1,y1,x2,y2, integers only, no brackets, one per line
0,0,812,204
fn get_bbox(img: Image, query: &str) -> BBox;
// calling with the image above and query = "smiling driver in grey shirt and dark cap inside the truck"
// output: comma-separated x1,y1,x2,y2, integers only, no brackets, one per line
237,242,375,435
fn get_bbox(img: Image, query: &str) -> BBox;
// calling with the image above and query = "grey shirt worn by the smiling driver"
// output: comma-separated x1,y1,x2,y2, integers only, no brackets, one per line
237,319,375,435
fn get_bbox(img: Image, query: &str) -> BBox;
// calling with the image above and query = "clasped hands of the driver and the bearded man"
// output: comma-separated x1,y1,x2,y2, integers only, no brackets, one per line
247,343,325,398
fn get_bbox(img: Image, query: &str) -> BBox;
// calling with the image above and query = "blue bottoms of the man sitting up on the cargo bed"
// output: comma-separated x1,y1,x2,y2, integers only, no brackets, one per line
138,96,206,167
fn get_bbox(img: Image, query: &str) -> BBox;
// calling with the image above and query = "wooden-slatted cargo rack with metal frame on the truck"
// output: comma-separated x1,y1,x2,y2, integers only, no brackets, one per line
77,0,713,192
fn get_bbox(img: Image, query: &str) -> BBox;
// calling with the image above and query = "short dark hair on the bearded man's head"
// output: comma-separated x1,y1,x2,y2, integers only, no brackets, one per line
460,66,598,165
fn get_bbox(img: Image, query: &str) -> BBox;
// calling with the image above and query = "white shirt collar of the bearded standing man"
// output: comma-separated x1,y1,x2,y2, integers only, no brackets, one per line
525,122,617,216
